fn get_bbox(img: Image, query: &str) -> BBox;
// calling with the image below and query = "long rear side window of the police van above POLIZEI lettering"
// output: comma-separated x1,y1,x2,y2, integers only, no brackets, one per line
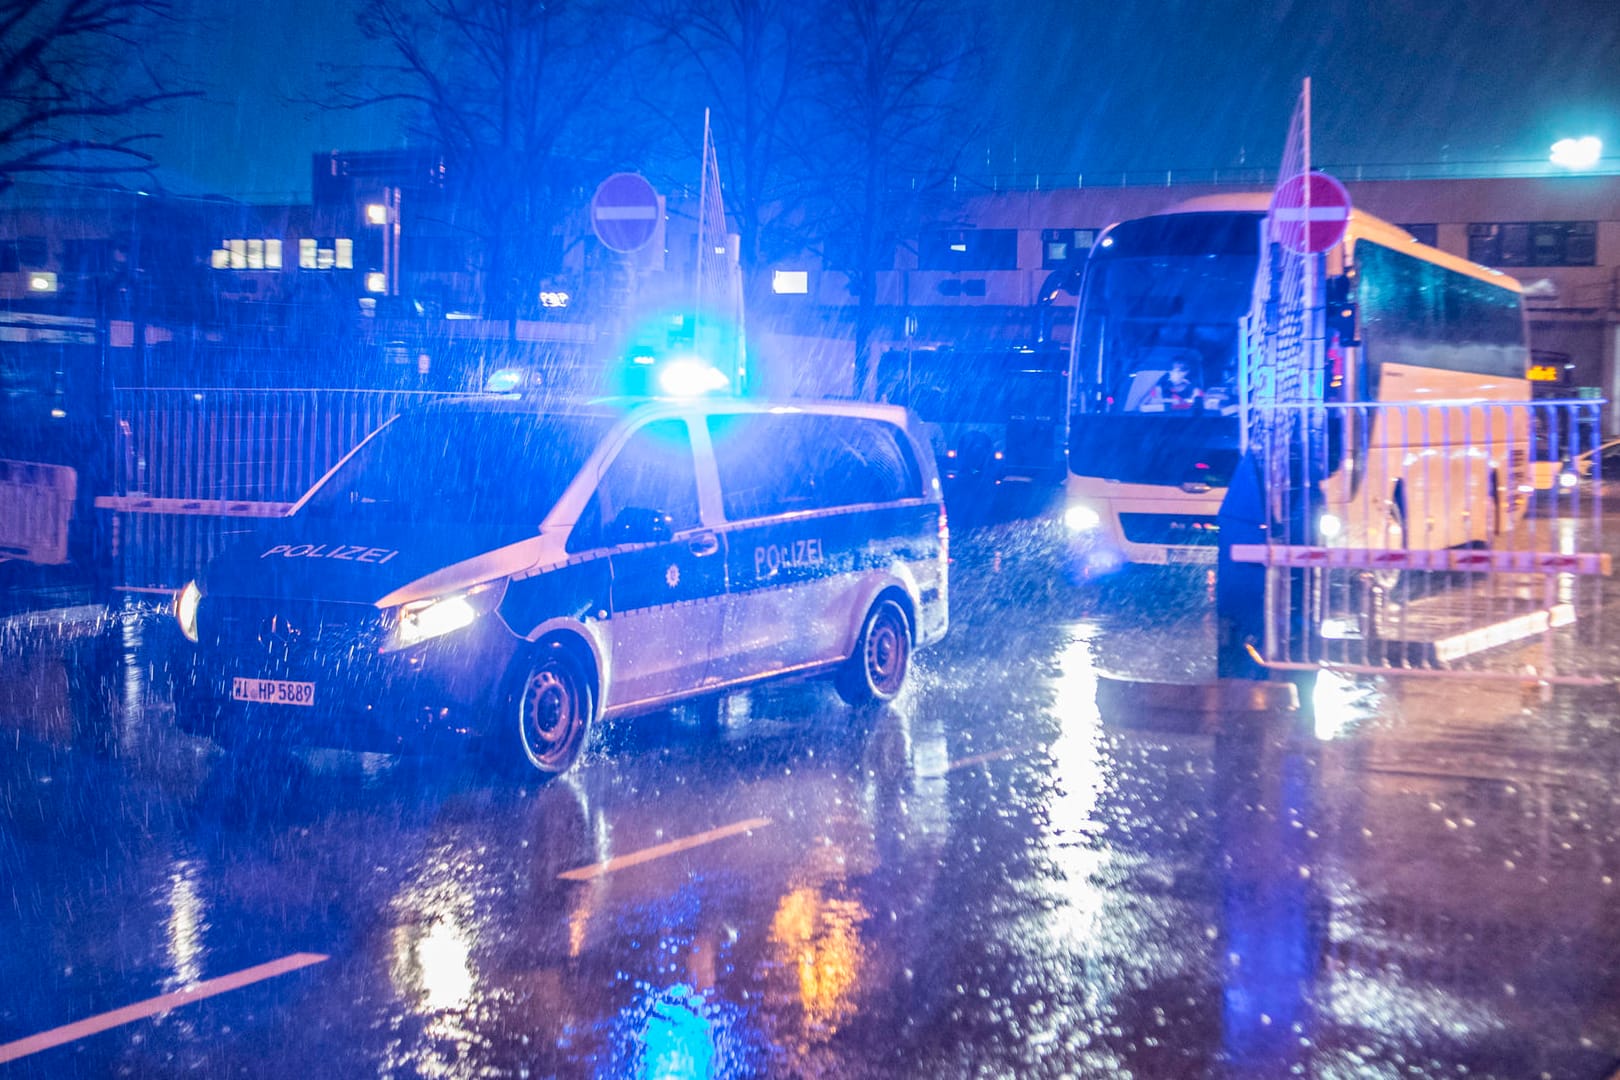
708,413,922,521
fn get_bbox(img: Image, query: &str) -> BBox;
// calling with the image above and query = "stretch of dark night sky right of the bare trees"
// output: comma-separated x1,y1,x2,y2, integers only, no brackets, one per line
991,0,1620,170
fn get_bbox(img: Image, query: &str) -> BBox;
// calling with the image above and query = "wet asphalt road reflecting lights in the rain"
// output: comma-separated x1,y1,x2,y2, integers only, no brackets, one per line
0,511,1620,1078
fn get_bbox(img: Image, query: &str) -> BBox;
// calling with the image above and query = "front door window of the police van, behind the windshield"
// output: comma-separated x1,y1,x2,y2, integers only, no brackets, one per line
567,419,701,551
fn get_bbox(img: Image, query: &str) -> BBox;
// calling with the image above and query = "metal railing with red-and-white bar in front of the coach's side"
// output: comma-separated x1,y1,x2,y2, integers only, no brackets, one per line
1231,400,1620,683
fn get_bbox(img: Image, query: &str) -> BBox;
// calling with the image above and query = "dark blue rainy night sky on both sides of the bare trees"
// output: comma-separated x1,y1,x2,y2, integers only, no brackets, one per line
142,0,1620,201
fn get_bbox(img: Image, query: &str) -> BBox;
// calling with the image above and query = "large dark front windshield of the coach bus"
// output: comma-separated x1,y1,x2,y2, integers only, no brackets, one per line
1074,214,1262,416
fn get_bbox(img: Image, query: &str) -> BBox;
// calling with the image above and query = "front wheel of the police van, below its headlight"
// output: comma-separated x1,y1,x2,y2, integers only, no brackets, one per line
494,641,593,776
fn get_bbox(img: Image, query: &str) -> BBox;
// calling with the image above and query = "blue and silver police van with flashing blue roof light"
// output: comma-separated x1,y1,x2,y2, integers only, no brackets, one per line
175,398,948,772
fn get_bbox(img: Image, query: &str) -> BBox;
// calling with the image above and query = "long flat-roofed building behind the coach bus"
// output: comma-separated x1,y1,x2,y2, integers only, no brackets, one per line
778,175,1620,417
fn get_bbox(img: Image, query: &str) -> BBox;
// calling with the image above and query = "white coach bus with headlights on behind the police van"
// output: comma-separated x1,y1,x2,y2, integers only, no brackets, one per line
1064,194,1531,568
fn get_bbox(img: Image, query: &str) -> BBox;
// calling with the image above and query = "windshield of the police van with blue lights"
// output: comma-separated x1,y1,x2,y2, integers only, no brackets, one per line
300,411,612,529
